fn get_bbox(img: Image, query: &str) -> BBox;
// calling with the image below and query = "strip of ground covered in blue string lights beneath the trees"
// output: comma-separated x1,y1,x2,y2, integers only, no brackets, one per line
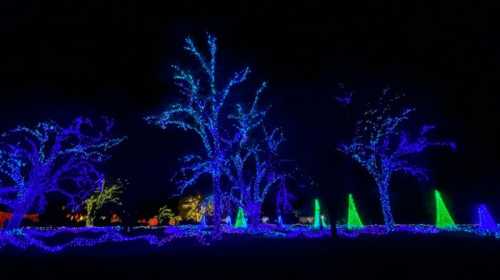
0,224,500,253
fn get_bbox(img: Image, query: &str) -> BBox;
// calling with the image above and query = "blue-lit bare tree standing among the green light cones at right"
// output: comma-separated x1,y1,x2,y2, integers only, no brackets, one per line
339,89,455,230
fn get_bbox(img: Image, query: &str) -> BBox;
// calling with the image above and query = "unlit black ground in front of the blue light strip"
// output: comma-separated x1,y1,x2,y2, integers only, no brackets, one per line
0,235,500,280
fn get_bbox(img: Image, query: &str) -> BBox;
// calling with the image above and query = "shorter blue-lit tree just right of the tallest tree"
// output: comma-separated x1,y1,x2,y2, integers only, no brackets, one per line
223,88,290,226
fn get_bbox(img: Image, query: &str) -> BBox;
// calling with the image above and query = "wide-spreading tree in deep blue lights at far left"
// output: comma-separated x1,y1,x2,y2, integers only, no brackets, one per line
0,117,124,229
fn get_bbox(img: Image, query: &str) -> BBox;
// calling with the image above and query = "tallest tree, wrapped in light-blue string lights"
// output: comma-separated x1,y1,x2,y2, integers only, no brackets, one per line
146,34,264,229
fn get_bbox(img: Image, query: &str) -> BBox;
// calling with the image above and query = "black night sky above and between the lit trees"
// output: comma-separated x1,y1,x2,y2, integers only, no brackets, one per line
0,1,500,223
